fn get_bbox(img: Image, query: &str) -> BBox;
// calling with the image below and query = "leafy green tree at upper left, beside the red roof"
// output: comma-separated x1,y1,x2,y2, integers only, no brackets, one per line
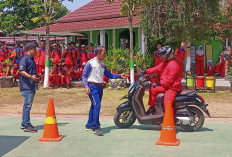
0,0,69,34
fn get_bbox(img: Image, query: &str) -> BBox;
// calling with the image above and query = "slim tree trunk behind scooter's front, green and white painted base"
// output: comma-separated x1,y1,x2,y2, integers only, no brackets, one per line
128,12,135,84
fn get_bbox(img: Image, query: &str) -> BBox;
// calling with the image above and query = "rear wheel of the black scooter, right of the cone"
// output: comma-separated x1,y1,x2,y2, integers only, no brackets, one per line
181,107,205,132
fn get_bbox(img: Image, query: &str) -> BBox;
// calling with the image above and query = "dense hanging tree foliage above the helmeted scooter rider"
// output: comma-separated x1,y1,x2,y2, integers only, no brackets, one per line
141,0,220,50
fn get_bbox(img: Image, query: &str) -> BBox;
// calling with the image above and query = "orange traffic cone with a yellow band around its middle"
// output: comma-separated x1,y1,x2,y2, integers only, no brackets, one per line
39,99,63,141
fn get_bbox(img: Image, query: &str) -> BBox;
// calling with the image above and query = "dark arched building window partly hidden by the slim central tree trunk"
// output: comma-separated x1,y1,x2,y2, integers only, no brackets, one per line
119,30,135,49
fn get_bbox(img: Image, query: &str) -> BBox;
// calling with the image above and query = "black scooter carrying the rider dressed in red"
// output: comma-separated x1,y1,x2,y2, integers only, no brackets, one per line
114,76,210,131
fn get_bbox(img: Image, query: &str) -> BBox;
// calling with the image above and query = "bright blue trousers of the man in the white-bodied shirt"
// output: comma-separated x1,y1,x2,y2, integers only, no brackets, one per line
86,85,103,130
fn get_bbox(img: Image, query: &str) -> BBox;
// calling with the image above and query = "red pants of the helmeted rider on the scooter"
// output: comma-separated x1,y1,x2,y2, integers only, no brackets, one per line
148,86,177,108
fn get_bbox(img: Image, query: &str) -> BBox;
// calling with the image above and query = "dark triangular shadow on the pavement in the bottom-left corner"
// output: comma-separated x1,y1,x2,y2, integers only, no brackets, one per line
0,136,30,156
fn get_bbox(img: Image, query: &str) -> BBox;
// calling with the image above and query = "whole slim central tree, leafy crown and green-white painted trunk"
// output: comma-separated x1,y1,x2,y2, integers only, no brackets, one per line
106,0,148,84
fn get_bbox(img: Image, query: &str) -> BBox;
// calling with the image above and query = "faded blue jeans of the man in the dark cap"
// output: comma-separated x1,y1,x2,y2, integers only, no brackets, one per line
21,90,35,127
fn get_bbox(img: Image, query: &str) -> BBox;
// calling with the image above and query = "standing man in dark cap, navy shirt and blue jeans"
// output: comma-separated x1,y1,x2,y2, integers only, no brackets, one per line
19,42,39,132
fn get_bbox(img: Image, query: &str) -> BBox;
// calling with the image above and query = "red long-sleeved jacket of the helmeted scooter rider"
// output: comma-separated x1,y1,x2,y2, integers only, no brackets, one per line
146,59,183,92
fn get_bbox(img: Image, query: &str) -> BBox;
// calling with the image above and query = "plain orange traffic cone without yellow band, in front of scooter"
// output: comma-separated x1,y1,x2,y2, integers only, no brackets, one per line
156,101,180,146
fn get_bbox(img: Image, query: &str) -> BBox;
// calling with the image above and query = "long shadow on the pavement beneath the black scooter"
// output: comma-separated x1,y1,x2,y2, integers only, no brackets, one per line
102,125,213,134
